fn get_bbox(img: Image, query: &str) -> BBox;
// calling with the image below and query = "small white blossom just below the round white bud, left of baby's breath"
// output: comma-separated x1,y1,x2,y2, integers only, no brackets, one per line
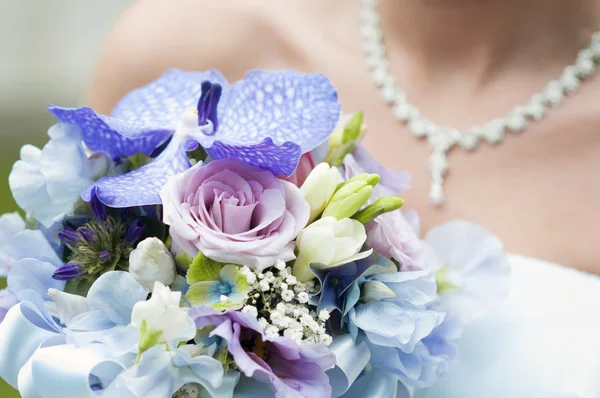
131,282,196,344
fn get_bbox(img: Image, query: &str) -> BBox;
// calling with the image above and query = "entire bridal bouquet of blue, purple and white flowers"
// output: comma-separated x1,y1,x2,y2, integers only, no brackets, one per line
0,70,508,398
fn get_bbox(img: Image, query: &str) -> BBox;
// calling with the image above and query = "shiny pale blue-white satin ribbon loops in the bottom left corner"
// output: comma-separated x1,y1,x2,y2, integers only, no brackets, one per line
0,302,124,398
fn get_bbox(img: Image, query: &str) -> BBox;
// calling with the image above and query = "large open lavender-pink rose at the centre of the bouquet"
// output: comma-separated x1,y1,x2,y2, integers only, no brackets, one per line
160,159,310,269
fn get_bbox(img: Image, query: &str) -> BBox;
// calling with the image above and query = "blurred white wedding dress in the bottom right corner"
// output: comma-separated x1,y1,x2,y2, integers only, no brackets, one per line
416,255,600,398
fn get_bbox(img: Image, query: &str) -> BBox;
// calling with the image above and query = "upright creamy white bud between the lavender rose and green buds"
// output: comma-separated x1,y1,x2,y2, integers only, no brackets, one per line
300,163,342,222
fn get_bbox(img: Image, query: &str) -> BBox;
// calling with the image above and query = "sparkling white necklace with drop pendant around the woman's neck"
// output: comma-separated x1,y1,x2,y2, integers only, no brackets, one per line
360,0,600,205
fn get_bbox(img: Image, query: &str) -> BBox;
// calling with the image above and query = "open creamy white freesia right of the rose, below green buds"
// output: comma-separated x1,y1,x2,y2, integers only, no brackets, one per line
294,217,373,282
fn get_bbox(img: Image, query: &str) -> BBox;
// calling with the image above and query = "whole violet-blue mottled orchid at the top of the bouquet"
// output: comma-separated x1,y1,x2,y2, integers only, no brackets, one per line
49,70,340,207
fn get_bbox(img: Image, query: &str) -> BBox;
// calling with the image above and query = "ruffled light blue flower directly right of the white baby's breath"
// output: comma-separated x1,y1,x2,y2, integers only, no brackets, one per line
314,254,445,386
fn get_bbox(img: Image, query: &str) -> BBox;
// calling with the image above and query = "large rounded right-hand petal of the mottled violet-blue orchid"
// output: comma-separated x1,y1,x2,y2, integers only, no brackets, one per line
195,70,340,177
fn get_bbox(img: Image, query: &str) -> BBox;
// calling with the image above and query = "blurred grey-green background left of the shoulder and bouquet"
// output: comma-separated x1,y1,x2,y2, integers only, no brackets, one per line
0,0,133,398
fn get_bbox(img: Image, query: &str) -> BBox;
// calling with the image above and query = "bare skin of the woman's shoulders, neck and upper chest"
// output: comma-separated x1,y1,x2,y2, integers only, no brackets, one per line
87,0,600,273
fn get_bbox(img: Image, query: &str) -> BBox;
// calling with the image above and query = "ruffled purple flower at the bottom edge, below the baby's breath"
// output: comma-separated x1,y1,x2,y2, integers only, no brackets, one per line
188,307,335,398
